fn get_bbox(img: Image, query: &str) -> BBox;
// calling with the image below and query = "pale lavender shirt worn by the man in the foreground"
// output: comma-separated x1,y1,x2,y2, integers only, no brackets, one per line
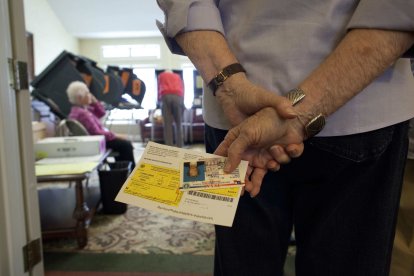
158,0,414,136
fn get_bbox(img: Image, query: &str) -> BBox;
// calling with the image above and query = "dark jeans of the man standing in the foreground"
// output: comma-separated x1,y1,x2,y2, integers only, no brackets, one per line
206,122,408,276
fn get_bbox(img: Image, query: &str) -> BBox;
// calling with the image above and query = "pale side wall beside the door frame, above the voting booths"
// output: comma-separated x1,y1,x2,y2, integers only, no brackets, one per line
24,0,80,75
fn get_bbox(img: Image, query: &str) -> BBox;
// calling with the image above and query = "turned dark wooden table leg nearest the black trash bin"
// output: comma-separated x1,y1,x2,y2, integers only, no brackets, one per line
73,180,90,248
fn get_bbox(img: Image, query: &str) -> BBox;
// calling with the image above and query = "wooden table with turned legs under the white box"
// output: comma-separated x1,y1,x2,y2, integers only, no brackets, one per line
37,151,110,248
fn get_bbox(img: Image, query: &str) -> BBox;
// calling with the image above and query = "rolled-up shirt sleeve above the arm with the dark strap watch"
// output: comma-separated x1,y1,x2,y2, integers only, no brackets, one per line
157,0,224,55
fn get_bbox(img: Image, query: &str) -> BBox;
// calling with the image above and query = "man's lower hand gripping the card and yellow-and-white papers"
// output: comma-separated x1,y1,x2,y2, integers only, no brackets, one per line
214,105,304,197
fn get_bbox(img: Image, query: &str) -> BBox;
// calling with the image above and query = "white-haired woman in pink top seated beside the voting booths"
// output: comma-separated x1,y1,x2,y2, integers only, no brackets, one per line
66,81,135,168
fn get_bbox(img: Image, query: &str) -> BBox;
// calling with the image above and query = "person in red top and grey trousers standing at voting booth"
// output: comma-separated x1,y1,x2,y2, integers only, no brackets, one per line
158,71,184,148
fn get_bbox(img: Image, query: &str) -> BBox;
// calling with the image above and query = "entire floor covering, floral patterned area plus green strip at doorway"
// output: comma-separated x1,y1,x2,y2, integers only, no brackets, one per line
43,144,295,276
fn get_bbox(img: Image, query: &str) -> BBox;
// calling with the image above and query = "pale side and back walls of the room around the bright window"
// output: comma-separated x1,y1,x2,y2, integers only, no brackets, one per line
24,0,189,80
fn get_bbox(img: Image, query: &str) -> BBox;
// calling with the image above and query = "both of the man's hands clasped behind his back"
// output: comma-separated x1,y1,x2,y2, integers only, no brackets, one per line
214,75,304,197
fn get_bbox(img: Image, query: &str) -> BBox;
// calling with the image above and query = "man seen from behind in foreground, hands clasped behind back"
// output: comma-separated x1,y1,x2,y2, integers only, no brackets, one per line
157,0,414,276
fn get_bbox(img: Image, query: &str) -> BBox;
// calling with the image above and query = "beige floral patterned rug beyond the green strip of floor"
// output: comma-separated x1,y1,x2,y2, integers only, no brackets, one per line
43,205,215,255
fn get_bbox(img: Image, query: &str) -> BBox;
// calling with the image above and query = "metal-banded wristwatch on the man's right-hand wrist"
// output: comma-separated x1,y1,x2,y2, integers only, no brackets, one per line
285,88,325,139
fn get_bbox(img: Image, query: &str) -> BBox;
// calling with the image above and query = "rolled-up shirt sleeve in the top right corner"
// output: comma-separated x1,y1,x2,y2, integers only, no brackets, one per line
348,0,414,57
